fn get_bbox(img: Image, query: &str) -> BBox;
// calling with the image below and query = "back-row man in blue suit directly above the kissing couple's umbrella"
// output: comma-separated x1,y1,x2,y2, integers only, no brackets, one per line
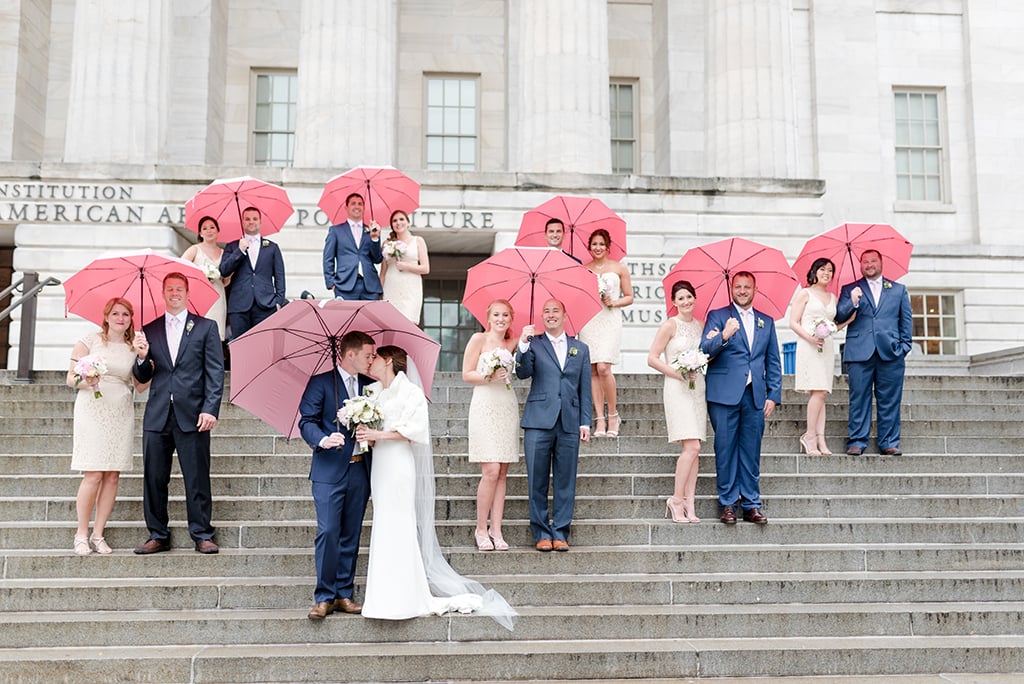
324,193,384,300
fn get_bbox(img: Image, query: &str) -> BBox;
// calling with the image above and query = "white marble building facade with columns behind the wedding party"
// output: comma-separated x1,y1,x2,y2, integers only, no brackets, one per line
0,0,1024,372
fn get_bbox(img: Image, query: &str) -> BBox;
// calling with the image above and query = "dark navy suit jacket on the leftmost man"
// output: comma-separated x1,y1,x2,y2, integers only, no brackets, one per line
132,313,224,432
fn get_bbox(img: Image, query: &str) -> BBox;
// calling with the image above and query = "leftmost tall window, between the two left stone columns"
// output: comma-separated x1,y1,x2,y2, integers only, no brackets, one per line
253,72,298,166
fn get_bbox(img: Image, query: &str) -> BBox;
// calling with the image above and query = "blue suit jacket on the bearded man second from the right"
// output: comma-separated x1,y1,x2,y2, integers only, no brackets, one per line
700,304,782,409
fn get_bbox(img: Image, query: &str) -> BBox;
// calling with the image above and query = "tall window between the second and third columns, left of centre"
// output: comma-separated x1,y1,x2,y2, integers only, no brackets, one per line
426,76,478,171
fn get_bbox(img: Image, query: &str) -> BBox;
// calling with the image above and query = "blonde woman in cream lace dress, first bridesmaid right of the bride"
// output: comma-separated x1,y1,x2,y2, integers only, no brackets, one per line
462,299,519,551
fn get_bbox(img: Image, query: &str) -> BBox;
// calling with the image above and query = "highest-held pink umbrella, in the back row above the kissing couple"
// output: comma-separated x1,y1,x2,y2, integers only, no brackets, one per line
316,166,420,226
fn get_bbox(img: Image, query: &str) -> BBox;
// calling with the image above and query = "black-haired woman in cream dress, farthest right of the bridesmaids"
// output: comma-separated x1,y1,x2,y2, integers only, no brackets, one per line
790,258,853,456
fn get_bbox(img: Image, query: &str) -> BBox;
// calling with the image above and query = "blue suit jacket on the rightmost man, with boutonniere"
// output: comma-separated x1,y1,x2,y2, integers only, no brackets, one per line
836,277,913,362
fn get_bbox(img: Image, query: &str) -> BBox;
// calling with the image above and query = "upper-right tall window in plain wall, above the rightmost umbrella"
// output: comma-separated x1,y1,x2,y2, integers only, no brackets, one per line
894,90,944,202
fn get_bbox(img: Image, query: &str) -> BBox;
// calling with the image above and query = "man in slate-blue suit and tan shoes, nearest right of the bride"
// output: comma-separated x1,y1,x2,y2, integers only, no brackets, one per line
515,299,593,551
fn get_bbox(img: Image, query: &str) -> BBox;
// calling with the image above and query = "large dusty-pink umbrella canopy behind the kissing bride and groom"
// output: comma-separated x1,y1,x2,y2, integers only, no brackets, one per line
230,299,440,438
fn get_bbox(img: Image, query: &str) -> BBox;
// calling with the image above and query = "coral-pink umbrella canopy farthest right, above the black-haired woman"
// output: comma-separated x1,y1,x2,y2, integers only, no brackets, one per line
793,223,913,296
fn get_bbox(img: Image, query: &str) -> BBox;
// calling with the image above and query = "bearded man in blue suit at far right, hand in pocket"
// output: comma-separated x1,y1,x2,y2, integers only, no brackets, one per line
836,250,913,456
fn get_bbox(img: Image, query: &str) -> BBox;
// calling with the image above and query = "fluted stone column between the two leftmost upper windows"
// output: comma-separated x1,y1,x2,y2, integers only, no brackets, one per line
295,0,398,169
